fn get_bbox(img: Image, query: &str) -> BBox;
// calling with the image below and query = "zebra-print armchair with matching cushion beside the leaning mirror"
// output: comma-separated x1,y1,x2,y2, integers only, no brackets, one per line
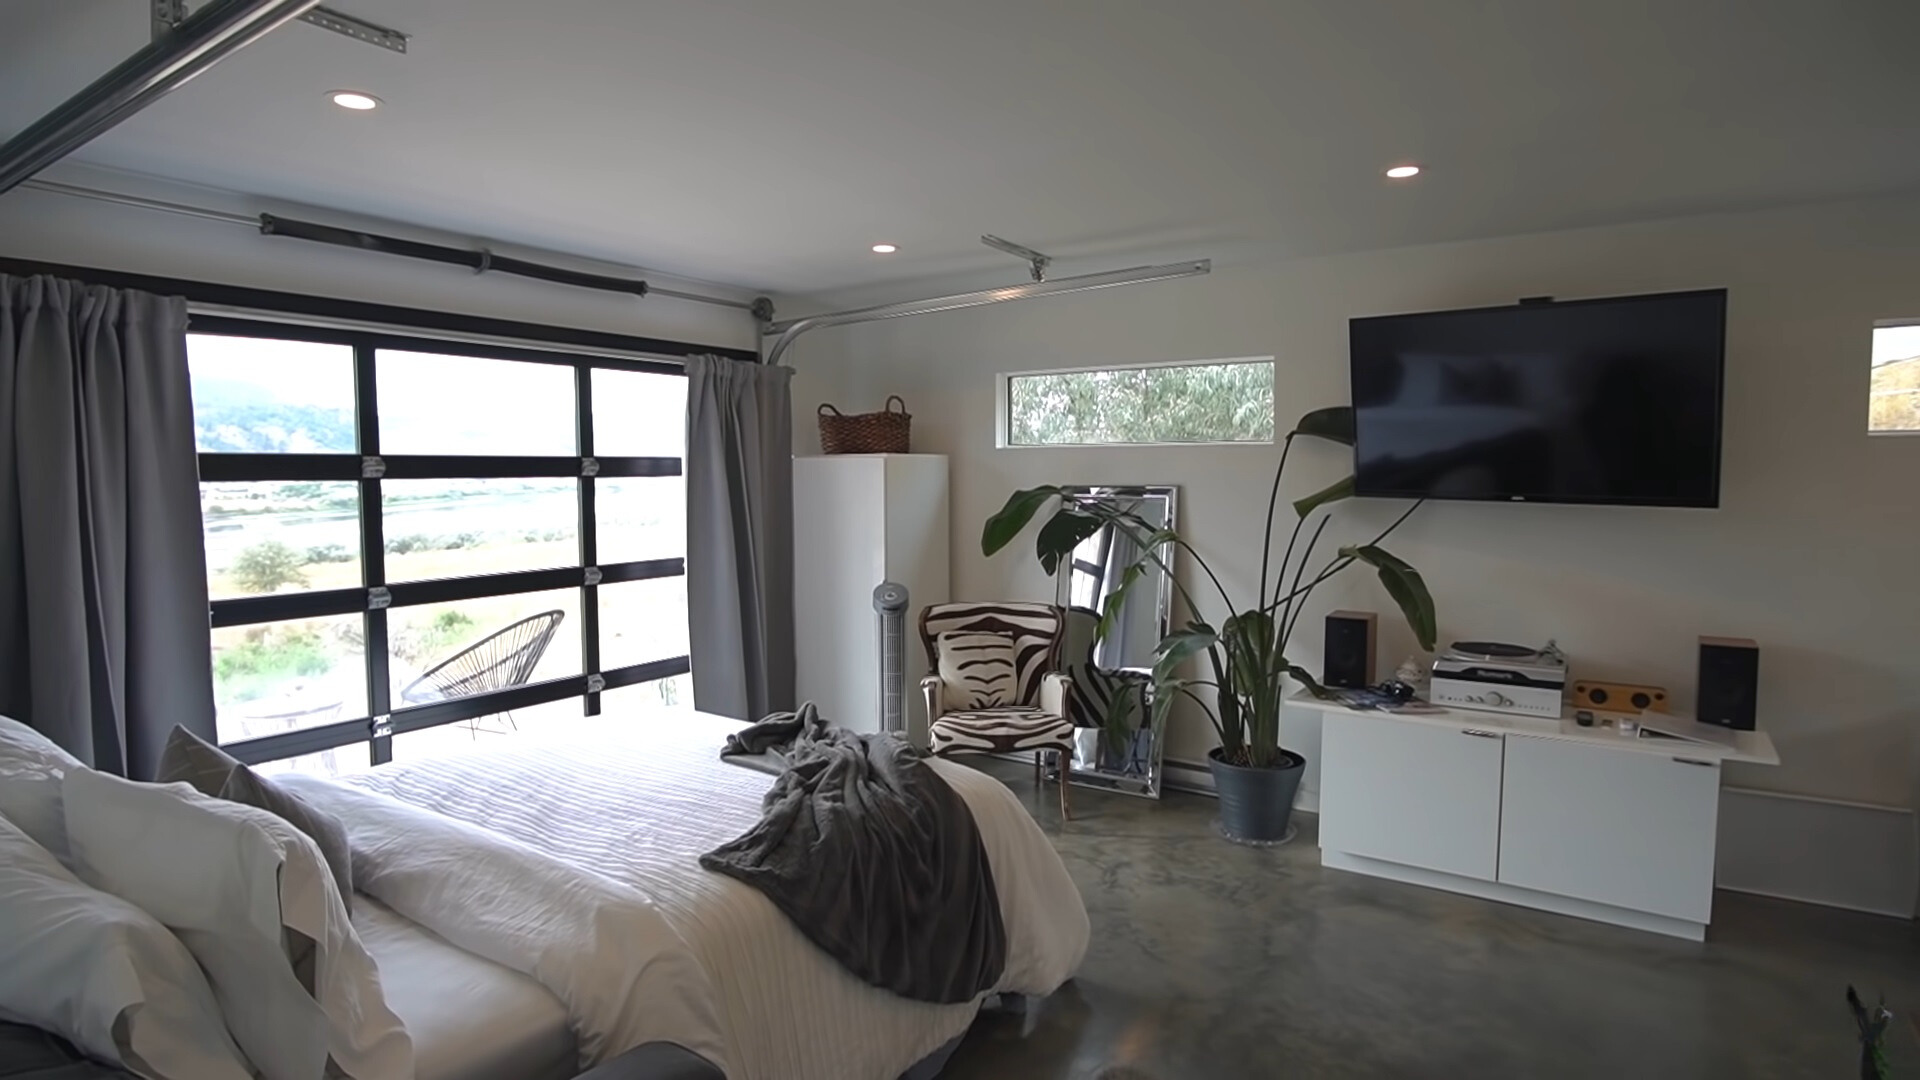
920,601,1073,817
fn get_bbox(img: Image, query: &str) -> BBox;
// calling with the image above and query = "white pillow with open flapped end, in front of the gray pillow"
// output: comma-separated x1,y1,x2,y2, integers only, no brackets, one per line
63,771,413,1080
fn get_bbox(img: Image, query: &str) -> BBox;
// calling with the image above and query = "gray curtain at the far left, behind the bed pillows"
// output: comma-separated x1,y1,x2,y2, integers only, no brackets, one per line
0,275,213,778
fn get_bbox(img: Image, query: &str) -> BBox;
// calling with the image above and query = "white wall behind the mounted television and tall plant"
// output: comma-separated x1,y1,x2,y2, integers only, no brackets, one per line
793,198,1920,805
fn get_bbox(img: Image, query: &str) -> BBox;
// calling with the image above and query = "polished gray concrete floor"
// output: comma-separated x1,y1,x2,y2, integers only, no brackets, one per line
943,763,1920,1080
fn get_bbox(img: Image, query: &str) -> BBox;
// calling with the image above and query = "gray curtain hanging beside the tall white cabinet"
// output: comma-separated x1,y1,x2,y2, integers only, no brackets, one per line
687,356,795,721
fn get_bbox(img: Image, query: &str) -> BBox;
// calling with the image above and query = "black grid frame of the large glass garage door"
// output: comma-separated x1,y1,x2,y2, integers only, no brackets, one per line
188,315,695,765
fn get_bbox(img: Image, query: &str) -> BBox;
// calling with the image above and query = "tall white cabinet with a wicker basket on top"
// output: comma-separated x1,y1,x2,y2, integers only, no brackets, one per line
793,454,950,746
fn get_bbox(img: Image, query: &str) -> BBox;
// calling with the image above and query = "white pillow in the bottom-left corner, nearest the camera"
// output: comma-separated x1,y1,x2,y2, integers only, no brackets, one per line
0,819,253,1080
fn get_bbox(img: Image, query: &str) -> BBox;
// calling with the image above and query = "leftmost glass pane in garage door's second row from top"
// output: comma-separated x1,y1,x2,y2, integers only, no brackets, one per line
200,480,365,600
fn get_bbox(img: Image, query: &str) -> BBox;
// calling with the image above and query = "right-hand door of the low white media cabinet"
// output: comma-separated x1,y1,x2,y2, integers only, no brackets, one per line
1500,736,1720,922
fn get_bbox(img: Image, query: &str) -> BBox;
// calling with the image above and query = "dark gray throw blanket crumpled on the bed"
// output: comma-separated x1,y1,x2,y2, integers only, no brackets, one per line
701,703,1006,1003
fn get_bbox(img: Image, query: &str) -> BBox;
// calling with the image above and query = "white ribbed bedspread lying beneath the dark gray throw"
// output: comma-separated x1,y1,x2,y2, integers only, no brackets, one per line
303,717,1089,1080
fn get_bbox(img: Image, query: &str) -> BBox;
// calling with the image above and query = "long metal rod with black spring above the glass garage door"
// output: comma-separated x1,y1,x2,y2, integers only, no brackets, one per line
25,181,774,323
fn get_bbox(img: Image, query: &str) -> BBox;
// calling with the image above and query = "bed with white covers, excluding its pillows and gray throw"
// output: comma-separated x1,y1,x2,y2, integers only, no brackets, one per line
286,715,1089,1080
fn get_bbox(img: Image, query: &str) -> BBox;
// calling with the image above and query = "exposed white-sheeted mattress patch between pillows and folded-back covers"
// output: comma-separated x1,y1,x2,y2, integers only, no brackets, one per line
353,896,580,1080
